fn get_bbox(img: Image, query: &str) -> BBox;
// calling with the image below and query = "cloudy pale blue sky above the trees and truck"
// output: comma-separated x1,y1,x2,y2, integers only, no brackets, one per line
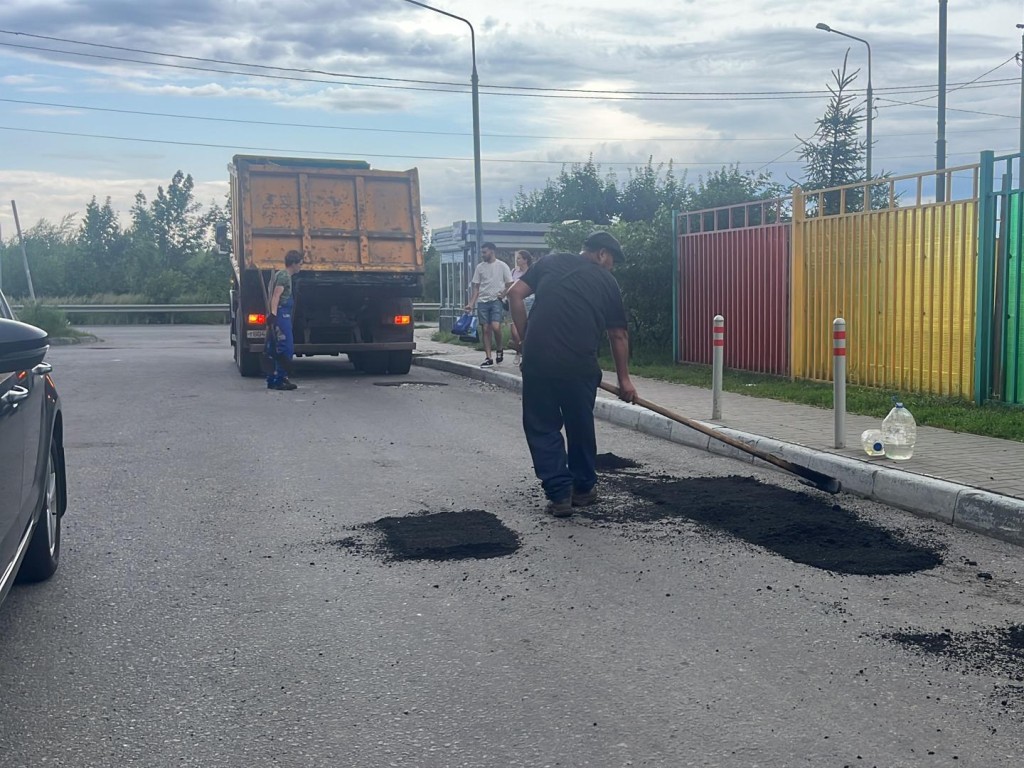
0,0,1024,240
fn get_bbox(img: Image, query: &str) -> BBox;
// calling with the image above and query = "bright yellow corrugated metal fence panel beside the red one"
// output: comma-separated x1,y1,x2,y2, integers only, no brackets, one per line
791,193,978,398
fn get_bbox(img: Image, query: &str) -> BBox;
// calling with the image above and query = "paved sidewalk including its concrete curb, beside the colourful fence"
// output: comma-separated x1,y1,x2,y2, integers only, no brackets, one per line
416,329,1024,544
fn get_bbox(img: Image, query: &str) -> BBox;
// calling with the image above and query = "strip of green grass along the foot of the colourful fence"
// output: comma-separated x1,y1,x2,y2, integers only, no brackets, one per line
601,351,1024,442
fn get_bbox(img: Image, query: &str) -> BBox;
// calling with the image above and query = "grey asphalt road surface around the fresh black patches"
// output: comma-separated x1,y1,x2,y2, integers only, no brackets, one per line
0,327,1024,768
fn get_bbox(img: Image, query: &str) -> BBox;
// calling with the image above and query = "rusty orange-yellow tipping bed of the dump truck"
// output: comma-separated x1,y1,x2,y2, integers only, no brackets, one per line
229,155,423,273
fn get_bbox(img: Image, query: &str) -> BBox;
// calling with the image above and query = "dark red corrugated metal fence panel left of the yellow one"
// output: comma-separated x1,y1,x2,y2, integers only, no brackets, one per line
677,223,791,376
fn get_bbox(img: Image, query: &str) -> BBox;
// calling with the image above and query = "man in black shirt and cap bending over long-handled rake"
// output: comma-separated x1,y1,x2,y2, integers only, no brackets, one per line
508,231,636,517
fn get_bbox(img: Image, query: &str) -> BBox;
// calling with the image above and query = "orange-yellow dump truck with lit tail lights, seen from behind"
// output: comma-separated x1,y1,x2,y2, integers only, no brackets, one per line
217,155,424,376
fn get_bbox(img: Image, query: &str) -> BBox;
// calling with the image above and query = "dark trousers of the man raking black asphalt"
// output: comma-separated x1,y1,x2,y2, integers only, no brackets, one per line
522,373,601,501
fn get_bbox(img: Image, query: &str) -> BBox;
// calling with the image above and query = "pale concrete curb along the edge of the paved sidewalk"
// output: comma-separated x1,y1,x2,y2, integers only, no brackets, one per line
413,355,1024,546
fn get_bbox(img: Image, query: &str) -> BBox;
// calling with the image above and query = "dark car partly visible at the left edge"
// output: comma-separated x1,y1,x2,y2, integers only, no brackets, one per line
0,294,68,600
